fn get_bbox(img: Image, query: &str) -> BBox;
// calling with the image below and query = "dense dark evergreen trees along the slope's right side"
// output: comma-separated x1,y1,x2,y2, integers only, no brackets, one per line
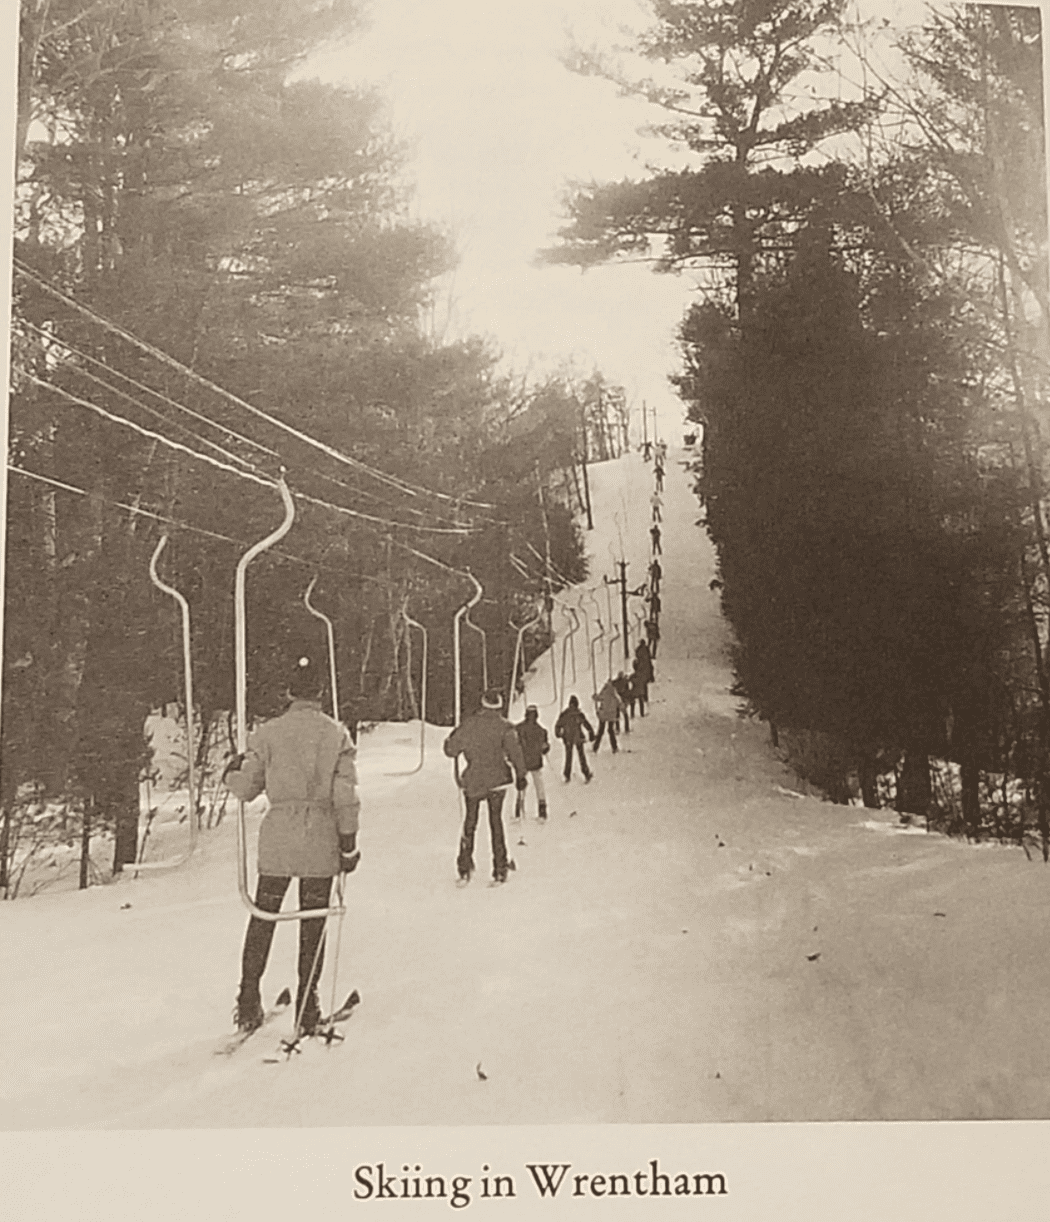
545,0,1050,860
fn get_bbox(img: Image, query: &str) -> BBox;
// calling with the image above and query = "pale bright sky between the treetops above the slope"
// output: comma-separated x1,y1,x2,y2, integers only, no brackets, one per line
308,0,693,433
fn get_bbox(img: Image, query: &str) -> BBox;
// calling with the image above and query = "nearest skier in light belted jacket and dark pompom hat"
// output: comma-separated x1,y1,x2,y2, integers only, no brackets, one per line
222,657,361,1035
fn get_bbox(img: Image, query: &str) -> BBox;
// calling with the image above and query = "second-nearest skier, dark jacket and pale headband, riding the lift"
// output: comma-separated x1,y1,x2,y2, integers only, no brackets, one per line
442,689,528,884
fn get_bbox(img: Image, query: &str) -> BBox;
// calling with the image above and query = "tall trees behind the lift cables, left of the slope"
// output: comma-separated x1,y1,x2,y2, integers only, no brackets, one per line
0,0,623,895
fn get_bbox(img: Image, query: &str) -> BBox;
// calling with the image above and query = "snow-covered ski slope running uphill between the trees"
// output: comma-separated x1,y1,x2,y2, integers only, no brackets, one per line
0,452,1050,1129
